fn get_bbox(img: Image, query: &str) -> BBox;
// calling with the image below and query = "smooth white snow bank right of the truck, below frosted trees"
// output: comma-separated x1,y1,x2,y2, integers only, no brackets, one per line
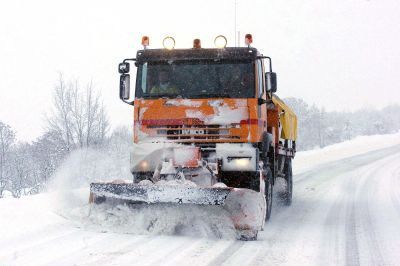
293,132,400,174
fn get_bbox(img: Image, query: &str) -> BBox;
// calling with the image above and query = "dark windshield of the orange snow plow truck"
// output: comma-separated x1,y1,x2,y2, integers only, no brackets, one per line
135,60,256,98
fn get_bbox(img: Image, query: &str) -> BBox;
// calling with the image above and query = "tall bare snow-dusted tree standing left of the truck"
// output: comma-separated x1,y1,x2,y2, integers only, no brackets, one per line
47,75,109,151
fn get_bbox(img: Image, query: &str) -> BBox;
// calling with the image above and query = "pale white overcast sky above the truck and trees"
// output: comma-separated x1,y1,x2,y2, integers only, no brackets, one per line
0,0,400,141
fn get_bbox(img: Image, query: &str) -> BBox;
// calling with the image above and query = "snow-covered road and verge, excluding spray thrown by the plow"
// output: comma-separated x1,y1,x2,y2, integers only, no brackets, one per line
0,135,400,266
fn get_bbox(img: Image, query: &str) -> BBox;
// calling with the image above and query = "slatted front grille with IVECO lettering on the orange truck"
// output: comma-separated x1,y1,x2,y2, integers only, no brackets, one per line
148,125,240,142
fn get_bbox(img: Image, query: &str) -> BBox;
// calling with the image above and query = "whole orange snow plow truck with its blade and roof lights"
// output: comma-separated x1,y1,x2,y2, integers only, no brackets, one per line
89,34,297,240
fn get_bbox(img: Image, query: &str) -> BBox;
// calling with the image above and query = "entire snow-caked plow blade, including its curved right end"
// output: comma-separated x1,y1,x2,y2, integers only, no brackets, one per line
89,183,266,240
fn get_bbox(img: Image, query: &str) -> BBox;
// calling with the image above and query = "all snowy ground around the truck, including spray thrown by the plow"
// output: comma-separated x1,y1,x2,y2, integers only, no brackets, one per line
0,133,400,266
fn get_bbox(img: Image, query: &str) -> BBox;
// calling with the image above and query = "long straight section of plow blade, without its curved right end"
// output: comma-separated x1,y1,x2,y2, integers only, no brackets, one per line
90,183,232,205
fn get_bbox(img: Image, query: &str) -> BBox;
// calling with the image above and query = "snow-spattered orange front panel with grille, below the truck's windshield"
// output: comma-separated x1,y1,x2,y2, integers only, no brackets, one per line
134,99,263,142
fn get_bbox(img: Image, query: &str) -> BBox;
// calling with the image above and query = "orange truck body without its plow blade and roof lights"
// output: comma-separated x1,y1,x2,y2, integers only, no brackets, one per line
119,40,297,209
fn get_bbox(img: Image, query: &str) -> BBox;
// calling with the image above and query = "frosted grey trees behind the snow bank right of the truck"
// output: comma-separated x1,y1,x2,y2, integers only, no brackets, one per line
284,98,400,150
